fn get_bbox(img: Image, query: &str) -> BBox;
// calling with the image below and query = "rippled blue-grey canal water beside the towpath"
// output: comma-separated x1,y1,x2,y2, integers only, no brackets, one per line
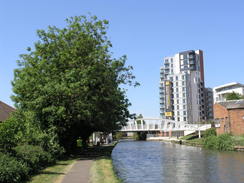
112,141,244,183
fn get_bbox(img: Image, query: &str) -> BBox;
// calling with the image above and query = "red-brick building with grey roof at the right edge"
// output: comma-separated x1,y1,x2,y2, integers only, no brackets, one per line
214,100,244,135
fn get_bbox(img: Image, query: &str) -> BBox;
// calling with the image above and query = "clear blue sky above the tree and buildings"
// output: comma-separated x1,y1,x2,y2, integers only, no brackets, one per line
0,0,244,117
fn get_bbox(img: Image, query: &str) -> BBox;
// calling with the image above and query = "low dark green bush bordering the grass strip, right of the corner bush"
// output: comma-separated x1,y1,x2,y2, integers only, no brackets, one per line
14,145,55,174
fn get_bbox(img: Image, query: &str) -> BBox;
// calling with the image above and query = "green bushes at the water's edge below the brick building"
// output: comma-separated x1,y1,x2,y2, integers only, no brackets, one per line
204,134,234,151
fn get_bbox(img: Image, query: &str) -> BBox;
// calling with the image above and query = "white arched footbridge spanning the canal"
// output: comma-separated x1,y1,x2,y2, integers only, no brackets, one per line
120,118,214,135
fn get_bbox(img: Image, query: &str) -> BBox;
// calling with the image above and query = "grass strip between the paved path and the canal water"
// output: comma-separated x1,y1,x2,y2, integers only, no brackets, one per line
91,157,122,183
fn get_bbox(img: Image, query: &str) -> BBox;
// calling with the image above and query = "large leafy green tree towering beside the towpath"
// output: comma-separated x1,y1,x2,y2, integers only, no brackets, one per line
13,16,137,150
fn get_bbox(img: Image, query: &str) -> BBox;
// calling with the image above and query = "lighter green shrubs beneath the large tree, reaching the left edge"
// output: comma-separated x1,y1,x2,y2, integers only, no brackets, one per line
0,110,64,158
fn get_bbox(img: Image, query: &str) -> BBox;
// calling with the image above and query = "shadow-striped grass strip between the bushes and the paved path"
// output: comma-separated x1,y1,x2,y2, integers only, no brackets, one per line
28,159,76,183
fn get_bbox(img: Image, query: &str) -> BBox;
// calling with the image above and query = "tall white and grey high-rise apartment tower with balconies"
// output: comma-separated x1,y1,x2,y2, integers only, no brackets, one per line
159,50,207,123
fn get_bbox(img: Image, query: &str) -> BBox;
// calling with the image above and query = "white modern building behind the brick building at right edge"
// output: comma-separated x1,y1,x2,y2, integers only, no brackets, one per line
213,82,244,103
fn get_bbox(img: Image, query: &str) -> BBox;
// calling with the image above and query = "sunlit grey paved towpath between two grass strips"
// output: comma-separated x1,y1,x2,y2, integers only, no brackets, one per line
61,159,93,183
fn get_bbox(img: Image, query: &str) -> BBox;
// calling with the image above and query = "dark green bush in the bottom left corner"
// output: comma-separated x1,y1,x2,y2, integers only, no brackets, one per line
0,153,28,183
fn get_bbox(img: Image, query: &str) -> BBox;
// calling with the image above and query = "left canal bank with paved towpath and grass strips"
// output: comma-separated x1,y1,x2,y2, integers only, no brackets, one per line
28,145,121,183
